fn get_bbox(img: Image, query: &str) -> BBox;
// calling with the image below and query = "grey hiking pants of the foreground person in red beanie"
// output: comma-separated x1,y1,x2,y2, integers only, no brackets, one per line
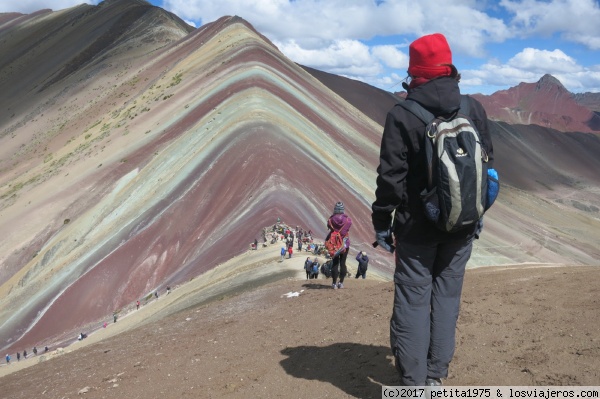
390,239,473,385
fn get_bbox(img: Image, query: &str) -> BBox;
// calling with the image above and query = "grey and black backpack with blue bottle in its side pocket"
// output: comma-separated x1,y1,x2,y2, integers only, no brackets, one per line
399,95,499,232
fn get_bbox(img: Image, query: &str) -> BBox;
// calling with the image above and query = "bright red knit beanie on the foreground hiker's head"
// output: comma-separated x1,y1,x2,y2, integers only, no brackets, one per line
408,33,452,79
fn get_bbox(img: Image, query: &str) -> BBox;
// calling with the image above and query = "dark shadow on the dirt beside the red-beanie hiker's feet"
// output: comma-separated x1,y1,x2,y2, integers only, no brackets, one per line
281,342,400,398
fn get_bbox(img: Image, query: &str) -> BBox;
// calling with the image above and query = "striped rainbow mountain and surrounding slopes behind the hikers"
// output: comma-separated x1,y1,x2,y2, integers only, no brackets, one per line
0,0,600,356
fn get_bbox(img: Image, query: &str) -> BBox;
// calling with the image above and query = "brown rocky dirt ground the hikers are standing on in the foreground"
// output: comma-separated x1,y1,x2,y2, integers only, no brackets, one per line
0,242,600,398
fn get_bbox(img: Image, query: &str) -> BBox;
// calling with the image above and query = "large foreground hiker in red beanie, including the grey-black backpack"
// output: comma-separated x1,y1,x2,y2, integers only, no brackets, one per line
372,33,498,386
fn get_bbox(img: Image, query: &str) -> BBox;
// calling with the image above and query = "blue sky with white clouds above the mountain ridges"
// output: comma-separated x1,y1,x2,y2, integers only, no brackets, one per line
0,0,600,94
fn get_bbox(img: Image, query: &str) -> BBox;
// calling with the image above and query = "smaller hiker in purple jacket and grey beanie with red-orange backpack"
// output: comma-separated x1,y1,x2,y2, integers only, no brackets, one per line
325,201,352,289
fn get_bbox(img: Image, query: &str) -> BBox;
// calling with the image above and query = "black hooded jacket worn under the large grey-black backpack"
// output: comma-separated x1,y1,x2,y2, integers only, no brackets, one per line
372,77,494,243
